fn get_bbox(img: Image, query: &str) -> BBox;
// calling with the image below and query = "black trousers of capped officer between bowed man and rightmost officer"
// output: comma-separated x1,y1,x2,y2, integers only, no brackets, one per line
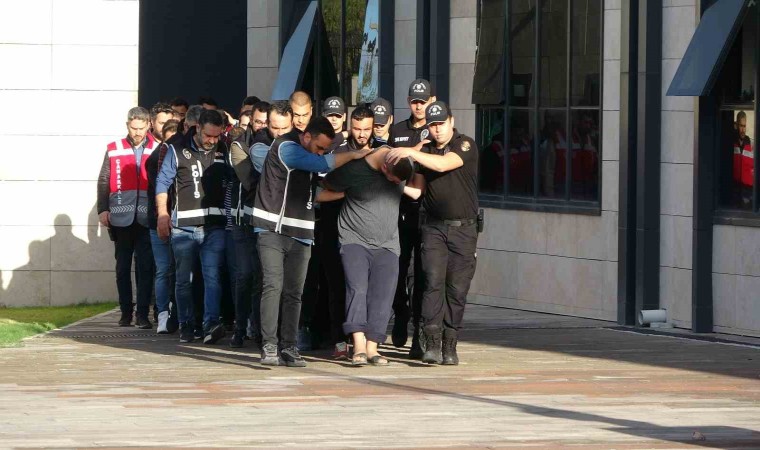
393,204,425,326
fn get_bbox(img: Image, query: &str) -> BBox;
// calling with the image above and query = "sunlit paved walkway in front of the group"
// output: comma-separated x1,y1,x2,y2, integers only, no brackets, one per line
0,305,760,449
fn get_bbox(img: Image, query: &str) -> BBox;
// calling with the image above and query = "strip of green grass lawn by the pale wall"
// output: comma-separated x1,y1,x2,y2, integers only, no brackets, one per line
0,303,118,347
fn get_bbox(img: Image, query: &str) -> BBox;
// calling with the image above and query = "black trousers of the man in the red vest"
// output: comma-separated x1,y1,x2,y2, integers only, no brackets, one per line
111,222,155,318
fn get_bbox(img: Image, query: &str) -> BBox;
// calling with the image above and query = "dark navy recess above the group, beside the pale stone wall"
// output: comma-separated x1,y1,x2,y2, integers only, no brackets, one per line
138,0,247,112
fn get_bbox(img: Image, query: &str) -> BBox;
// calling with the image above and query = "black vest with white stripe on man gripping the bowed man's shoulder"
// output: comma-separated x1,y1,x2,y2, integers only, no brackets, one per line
252,131,314,240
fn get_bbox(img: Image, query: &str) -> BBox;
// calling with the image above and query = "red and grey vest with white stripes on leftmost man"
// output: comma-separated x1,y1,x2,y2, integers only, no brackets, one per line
107,136,157,227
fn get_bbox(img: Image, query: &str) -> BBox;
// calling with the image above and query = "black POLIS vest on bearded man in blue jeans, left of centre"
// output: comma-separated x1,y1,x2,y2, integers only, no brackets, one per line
173,132,229,227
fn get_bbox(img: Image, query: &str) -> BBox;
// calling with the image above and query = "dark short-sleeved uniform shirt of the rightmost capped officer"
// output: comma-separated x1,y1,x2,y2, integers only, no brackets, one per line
420,130,478,220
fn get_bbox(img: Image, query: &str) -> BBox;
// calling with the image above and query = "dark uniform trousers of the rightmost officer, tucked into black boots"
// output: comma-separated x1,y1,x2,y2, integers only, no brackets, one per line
422,224,478,330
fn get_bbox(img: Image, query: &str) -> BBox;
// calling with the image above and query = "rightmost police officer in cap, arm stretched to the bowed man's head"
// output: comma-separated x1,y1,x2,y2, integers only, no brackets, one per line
392,102,478,365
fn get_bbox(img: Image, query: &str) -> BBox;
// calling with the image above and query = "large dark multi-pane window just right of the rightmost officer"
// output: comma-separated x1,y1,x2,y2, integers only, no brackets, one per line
473,0,603,212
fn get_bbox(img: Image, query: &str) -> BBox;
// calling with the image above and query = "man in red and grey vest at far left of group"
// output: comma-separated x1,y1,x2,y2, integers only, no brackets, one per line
97,107,157,329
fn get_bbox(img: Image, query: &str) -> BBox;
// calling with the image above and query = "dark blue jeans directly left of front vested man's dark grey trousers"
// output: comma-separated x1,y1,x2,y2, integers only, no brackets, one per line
232,225,261,335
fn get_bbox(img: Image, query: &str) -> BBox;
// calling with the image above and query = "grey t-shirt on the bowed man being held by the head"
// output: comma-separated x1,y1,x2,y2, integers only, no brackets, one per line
325,159,404,255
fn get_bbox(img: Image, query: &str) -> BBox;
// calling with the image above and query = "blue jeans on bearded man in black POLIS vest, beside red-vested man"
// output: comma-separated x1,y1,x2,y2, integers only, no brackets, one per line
172,227,224,327
